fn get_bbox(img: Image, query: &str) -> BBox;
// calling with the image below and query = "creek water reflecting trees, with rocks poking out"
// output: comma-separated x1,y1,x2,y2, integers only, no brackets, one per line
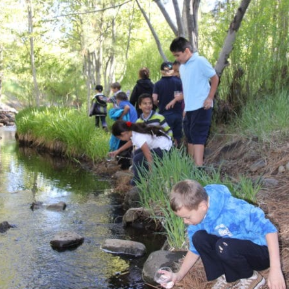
0,128,164,289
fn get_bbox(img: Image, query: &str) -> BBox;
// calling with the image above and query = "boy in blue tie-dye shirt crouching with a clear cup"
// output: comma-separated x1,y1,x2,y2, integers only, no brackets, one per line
163,180,286,289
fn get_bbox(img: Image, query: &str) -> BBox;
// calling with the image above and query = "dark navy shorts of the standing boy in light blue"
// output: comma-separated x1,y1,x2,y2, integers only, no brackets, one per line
184,108,213,145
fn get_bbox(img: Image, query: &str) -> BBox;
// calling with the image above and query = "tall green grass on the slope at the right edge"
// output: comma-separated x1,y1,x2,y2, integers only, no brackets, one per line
230,90,289,142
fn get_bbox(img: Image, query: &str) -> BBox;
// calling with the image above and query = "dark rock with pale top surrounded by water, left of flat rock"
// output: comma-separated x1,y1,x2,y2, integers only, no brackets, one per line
50,231,84,251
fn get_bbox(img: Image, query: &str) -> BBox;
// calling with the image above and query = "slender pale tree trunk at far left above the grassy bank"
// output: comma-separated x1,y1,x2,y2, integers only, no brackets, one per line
26,0,40,107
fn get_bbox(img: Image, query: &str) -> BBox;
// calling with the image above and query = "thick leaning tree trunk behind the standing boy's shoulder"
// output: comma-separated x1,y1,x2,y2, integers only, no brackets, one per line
215,0,251,77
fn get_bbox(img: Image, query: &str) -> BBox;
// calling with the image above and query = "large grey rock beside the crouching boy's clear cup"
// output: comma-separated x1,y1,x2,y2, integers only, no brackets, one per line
142,250,187,285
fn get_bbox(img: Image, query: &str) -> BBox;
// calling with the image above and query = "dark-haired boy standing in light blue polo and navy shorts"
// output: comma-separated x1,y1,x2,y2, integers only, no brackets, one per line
167,37,219,166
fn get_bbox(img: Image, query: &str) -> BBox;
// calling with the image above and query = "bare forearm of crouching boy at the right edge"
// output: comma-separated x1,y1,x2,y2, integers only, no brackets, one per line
266,233,286,289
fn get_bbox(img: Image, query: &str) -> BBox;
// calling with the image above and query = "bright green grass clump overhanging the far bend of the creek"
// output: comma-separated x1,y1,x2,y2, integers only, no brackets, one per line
16,107,110,160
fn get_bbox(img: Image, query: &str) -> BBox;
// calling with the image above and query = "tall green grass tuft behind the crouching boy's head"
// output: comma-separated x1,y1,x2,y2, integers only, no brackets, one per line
137,149,259,249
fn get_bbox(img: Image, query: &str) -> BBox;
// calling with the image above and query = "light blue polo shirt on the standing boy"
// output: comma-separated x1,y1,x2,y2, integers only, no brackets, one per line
180,52,216,111
